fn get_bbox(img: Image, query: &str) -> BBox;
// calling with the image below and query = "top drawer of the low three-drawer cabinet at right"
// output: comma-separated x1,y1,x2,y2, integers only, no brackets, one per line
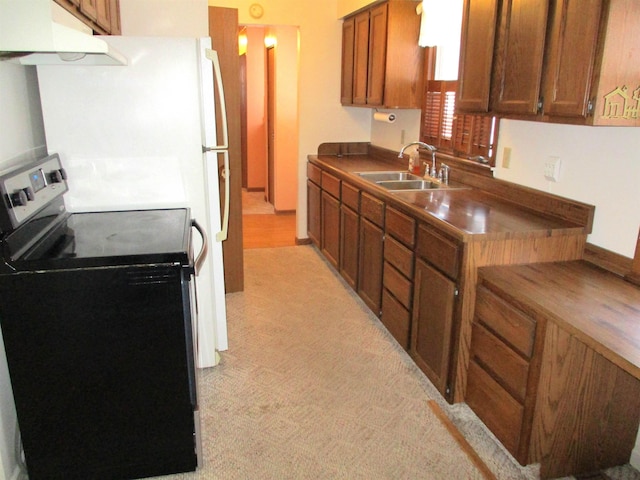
475,284,536,358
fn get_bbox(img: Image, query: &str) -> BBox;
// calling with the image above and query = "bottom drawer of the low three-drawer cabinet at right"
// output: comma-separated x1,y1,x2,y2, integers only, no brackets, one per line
465,360,524,456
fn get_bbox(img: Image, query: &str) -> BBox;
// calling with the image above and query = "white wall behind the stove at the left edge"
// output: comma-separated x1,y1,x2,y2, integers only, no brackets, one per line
0,61,45,480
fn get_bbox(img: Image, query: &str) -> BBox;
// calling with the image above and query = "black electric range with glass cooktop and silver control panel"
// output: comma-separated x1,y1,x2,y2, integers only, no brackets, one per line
0,154,206,480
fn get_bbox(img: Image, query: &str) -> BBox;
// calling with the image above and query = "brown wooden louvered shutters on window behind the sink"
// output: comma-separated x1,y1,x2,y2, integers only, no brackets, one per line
420,80,498,166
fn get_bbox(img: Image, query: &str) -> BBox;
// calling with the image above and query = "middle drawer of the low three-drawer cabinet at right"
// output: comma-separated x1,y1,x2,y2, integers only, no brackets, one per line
471,323,529,404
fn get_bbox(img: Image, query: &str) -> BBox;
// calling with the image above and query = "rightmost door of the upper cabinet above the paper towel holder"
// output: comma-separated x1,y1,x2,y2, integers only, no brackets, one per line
367,3,388,105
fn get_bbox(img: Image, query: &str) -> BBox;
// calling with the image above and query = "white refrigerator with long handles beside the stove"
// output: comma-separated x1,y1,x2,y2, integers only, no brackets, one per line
37,36,229,368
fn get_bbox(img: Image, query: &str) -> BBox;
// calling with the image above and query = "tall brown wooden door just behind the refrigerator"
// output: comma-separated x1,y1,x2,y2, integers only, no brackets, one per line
209,7,244,293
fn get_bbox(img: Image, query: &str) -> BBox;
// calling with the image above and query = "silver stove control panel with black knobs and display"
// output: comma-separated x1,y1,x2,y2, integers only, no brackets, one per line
0,153,69,232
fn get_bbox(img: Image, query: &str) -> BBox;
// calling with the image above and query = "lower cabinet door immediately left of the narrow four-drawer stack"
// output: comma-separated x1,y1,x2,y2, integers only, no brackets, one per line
358,218,384,317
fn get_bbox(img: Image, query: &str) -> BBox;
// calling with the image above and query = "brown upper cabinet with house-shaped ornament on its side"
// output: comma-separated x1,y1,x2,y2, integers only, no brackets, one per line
457,0,640,126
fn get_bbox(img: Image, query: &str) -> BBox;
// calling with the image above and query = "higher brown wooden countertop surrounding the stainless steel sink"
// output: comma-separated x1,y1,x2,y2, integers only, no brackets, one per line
309,155,586,242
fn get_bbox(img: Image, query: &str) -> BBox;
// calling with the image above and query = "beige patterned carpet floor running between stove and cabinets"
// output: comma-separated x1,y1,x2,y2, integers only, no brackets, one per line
150,246,640,480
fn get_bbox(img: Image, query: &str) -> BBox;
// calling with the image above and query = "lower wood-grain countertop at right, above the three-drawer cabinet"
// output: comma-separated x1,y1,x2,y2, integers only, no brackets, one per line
479,260,640,379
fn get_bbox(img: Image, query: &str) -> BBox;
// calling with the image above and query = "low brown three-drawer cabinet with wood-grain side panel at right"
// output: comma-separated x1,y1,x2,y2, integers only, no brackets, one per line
465,267,640,478
